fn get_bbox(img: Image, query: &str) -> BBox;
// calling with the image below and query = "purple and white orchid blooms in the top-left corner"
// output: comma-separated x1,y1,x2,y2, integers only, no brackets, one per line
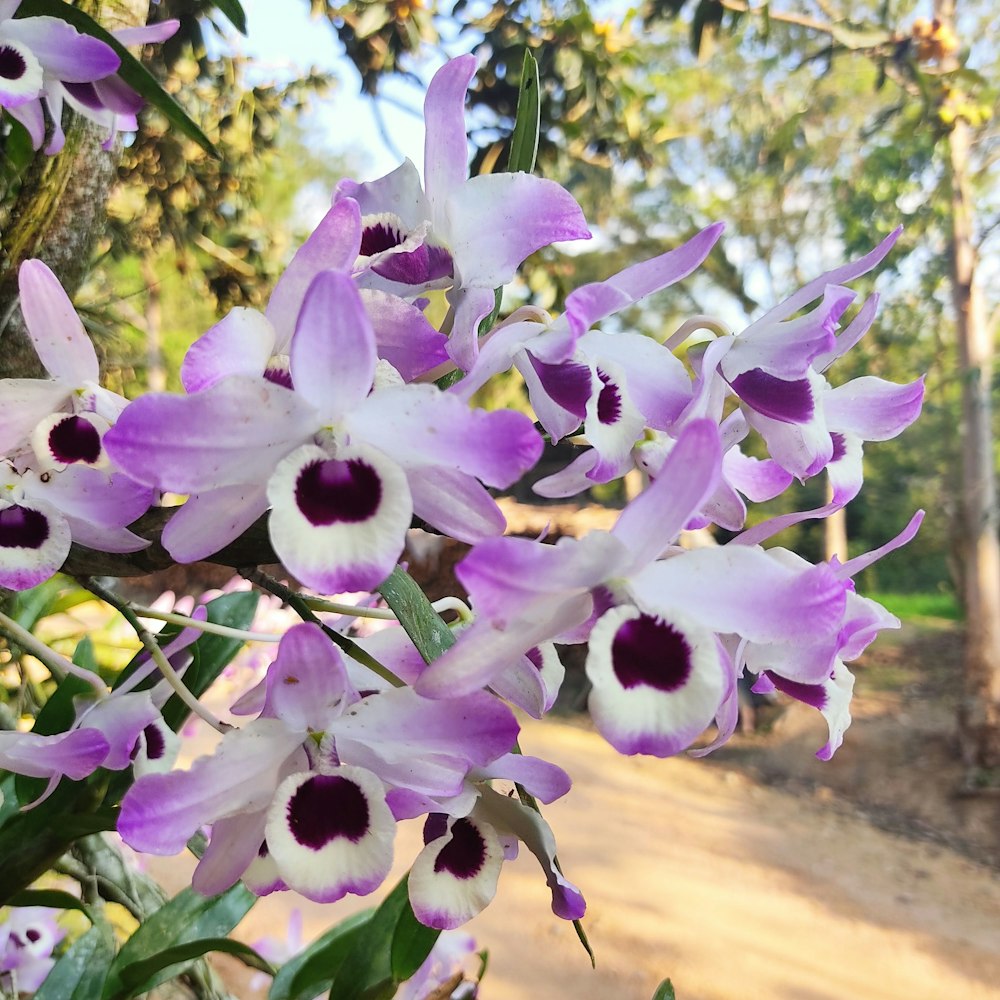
0,0,179,154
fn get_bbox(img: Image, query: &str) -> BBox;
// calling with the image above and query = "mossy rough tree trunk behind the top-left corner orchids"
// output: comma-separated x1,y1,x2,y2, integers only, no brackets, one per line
0,0,149,378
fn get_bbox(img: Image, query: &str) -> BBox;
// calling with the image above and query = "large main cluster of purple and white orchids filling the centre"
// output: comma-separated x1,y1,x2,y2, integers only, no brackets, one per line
0,52,923,928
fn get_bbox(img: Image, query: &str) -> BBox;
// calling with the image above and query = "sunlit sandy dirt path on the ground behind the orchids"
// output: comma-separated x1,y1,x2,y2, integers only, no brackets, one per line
145,722,1000,1000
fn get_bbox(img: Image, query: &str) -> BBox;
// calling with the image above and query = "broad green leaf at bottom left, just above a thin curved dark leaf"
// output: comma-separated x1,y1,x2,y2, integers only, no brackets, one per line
102,882,257,1000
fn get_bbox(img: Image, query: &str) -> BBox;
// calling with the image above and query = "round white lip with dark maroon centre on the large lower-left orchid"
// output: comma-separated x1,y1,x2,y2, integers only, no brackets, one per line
266,767,396,903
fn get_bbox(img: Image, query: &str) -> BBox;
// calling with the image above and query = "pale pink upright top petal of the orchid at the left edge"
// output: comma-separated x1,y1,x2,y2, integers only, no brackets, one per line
17,258,98,388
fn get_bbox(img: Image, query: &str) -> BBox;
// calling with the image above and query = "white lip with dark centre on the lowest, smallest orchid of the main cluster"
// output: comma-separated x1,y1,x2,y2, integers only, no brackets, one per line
408,816,503,930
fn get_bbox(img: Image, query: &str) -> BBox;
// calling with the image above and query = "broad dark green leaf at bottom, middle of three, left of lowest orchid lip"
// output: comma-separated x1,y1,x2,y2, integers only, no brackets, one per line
330,876,441,1000
